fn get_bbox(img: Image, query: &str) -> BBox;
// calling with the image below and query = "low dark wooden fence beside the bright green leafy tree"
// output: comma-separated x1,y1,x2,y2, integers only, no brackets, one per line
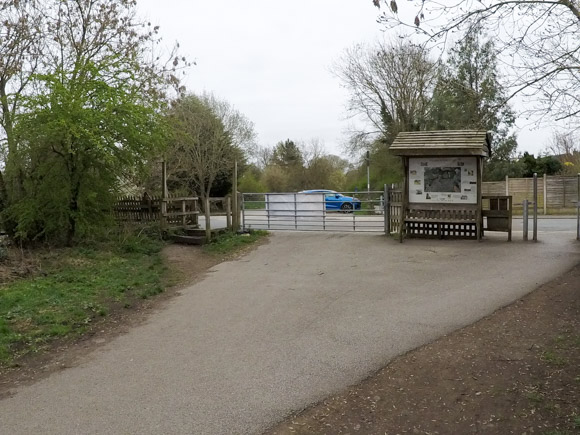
113,196,199,226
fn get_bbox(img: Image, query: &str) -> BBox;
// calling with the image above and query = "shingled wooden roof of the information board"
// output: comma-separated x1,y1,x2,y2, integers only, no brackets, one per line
390,130,491,157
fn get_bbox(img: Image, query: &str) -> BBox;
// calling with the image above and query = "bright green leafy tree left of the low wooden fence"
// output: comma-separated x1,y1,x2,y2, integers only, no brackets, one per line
8,69,162,244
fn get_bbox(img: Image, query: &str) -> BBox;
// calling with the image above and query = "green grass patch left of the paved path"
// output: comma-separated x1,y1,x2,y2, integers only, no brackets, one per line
0,236,166,366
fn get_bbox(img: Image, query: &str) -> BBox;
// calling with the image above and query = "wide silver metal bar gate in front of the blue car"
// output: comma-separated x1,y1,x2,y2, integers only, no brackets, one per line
242,187,397,234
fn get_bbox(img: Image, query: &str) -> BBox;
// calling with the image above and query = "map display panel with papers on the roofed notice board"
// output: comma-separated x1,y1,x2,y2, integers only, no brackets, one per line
408,157,477,204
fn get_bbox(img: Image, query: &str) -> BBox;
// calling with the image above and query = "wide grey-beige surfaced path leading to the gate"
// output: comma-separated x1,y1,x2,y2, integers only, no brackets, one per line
0,233,580,435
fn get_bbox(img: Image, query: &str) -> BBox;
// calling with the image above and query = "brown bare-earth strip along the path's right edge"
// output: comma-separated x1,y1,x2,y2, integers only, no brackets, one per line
266,266,580,435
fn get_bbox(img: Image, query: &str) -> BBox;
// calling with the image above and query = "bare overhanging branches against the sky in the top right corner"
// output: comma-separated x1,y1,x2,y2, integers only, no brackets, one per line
373,0,580,128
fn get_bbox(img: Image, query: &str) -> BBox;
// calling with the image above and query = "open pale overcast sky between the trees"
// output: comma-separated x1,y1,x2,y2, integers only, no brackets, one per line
138,0,550,160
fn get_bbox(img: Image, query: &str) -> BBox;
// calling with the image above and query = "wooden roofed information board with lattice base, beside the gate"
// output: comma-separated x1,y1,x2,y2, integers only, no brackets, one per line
390,130,502,241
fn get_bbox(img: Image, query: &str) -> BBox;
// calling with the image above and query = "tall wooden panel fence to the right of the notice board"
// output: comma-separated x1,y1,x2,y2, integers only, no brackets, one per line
482,175,579,212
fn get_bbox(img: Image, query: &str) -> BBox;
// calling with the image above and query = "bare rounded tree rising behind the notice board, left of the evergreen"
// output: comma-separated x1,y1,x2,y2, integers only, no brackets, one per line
334,40,438,150
